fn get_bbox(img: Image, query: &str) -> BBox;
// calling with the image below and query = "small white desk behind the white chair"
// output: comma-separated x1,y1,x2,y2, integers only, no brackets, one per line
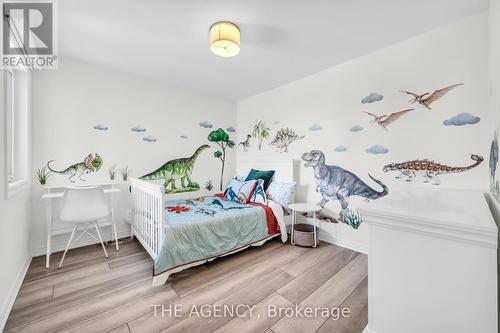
41,183,120,268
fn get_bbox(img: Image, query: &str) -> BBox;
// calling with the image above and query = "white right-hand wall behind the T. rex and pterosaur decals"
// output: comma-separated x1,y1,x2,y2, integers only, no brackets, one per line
238,13,493,251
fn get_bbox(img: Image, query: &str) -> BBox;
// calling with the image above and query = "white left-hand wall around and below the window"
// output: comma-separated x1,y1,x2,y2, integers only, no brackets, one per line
0,71,31,331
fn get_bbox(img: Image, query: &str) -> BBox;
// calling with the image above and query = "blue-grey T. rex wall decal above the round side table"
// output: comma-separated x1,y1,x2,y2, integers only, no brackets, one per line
302,150,389,221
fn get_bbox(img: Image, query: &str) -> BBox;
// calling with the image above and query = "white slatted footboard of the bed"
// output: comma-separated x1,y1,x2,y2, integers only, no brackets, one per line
130,178,165,259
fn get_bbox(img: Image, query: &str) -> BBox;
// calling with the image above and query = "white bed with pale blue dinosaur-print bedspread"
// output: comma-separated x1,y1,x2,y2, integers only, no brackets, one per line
130,160,294,285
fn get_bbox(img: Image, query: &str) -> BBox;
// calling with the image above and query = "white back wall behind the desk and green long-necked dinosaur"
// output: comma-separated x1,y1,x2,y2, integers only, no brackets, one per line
31,58,236,254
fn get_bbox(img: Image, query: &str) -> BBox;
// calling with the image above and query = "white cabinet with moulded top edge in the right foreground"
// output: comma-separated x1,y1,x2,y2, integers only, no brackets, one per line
359,188,497,333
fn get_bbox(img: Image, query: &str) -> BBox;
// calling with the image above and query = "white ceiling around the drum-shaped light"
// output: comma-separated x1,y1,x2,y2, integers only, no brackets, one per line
58,0,488,100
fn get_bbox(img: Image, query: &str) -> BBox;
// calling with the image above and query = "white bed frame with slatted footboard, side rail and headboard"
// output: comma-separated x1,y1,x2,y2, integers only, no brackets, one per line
130,159,296,273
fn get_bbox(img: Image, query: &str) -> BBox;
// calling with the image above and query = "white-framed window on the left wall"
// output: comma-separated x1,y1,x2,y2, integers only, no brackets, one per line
3,70,31,198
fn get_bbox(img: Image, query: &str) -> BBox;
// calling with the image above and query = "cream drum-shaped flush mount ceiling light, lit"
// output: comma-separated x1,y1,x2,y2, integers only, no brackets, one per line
210,21,240,57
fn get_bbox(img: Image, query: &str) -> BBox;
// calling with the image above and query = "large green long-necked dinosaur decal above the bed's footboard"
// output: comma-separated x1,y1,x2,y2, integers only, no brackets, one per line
140,145,210,193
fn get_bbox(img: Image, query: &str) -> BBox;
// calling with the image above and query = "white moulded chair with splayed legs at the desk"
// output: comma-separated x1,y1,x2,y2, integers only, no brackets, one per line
59,186,119,268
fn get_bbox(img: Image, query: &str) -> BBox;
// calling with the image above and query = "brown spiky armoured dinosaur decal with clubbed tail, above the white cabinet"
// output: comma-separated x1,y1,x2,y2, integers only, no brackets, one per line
384,154,484,185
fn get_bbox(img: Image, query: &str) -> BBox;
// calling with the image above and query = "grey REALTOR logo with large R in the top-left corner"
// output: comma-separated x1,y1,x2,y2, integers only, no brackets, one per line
1,0,57,70
